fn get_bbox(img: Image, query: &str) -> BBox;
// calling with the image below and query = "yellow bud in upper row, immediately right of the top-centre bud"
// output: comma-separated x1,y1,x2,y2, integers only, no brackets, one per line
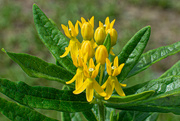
94,27,106,45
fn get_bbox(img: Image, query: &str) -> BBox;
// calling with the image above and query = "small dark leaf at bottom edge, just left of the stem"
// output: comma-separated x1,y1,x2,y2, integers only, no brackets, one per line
82,110,98,121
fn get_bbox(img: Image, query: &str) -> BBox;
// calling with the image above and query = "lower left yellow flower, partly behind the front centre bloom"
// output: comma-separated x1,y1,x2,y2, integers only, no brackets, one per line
66,50,87,89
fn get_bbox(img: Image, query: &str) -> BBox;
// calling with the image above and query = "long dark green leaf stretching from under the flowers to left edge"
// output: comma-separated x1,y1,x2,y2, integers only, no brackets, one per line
0,79,93,112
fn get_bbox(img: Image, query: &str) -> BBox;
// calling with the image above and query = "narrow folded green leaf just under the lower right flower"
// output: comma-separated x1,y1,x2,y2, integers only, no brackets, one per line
107,90,154,103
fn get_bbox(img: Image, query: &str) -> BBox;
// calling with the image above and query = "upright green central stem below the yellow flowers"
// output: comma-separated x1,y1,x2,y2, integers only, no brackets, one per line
98,100,105,121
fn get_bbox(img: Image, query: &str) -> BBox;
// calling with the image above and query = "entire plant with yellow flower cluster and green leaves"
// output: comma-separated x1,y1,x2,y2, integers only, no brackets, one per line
0,4,180,121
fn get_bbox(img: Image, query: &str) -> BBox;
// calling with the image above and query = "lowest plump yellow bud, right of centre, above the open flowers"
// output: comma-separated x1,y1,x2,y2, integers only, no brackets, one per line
95,45,108,65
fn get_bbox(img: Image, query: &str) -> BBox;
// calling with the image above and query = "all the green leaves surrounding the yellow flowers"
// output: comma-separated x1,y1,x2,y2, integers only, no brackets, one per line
0,4,180,121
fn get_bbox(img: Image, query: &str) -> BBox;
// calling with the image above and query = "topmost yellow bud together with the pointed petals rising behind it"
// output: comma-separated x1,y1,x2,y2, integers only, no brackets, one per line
79,16,94,40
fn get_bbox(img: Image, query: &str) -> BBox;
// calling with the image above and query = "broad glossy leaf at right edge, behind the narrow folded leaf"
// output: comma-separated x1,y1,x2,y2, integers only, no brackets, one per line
105,76,180,115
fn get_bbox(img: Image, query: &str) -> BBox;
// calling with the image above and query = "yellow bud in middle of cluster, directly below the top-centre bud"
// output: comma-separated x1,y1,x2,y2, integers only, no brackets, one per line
81,40,95,60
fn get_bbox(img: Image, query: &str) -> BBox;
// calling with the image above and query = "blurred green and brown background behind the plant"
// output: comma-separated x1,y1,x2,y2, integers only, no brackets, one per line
0,0,180,121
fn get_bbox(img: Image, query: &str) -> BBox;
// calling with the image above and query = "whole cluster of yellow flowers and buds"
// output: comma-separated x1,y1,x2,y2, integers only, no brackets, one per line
60,16,126,102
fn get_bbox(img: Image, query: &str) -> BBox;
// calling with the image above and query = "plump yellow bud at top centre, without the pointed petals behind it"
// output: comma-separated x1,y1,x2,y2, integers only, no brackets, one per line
81,22,94,40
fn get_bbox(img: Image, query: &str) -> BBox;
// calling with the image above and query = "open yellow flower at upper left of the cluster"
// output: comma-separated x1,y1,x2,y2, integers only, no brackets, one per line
60,21,81,63
